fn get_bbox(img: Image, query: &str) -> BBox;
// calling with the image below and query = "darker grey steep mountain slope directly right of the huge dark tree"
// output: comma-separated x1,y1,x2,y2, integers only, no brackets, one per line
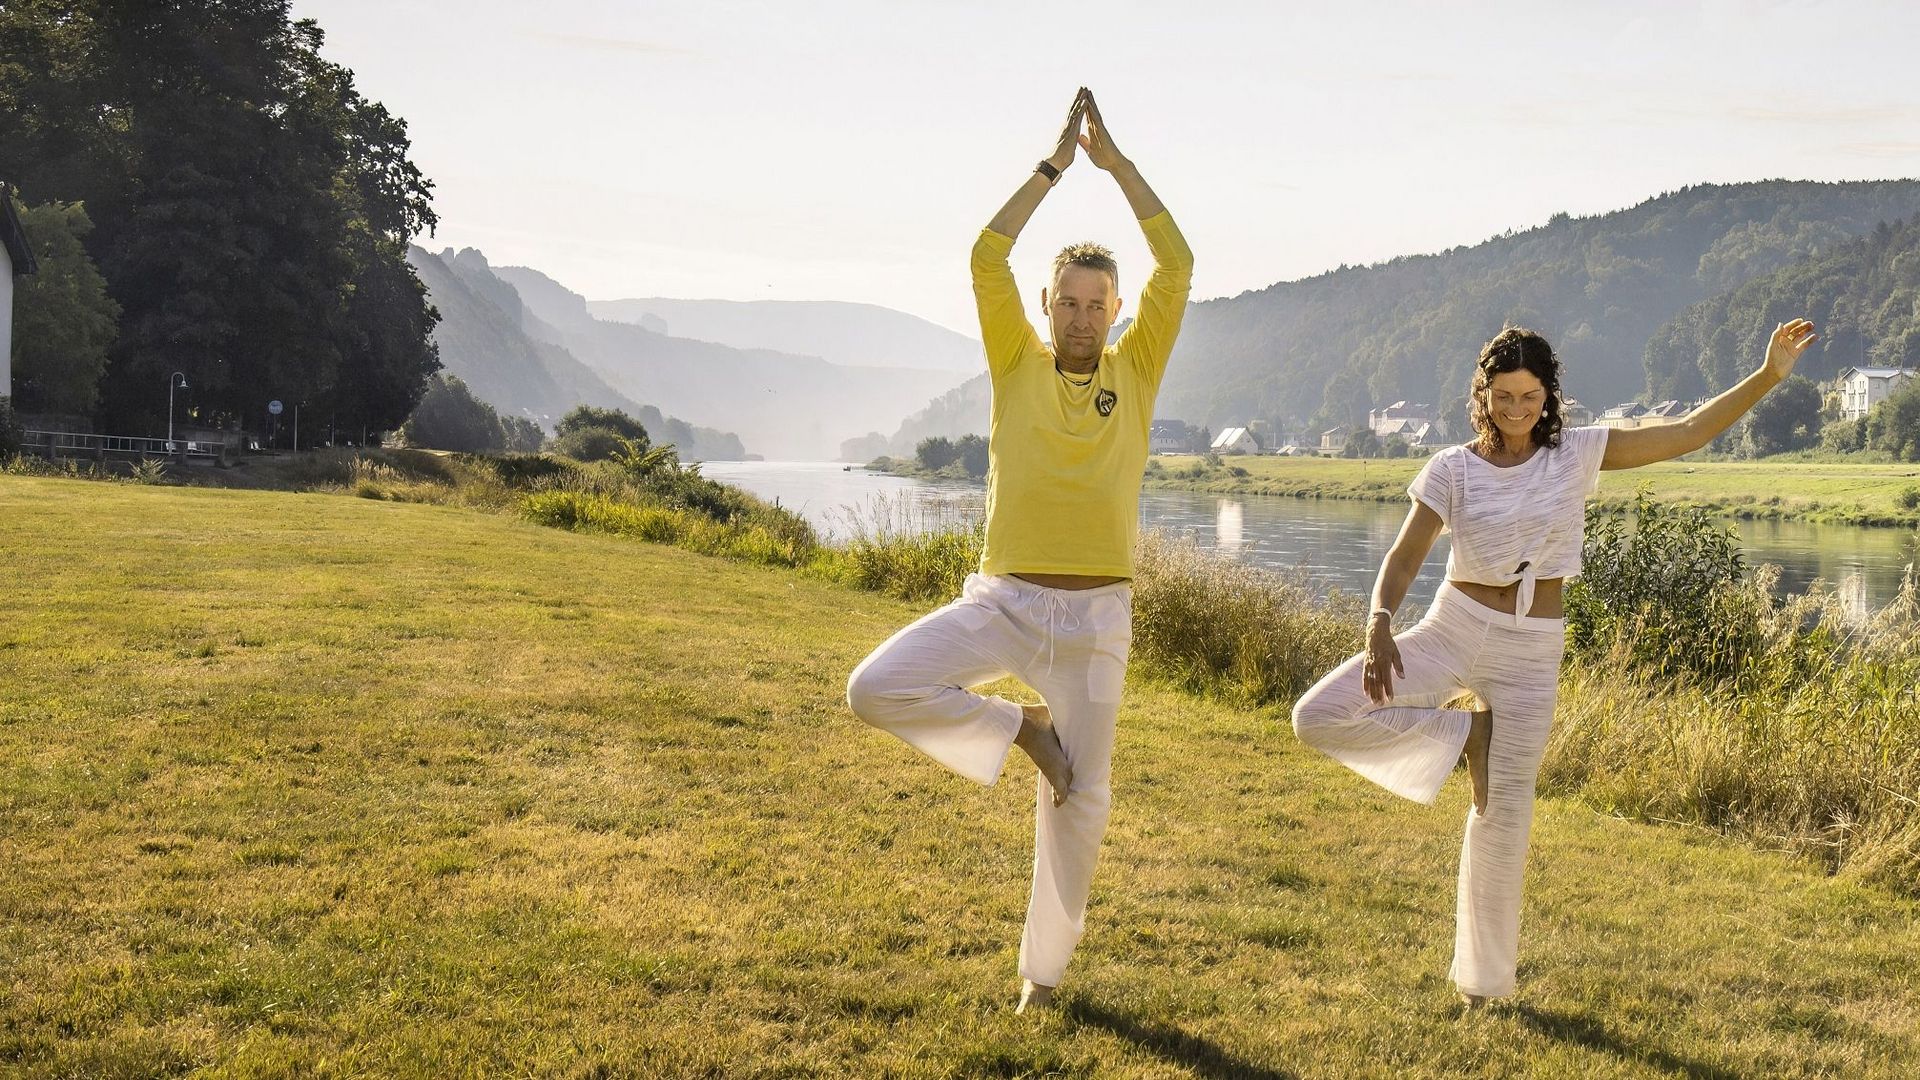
407,246,747,459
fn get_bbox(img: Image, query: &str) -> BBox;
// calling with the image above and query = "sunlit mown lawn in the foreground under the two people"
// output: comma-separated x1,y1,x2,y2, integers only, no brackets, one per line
0,477,1920,1078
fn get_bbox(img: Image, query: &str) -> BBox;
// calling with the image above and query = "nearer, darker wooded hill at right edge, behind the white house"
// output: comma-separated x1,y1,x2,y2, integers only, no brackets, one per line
1645,217,1920,398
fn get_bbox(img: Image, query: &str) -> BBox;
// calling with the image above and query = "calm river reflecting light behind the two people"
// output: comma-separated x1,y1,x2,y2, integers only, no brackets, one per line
703,461,1912,609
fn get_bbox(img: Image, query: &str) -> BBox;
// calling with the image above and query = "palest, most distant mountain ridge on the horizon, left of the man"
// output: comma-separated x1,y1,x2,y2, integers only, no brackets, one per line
586,296,981,375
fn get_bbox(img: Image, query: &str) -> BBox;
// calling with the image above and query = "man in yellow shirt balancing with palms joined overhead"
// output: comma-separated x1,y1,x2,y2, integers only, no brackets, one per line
847,86,1192,1011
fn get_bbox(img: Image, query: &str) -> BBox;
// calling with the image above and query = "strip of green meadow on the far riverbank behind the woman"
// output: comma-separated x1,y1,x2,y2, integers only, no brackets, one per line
1146,455,1920,527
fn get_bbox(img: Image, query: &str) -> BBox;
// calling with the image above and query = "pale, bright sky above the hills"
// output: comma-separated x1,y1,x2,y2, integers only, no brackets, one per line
294,0,1920,334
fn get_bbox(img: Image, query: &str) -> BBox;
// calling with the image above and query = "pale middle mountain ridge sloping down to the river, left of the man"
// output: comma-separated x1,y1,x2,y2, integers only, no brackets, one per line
495,267,964,459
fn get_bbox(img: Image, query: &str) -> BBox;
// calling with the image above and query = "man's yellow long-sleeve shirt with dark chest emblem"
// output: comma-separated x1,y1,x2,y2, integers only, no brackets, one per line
973,211,1194,577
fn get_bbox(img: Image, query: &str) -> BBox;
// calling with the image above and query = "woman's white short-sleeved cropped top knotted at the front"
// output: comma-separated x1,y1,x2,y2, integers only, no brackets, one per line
1407,427,1607,623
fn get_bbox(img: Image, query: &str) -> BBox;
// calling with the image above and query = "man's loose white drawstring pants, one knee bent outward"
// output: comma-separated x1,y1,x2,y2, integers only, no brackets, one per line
847,575,1133,986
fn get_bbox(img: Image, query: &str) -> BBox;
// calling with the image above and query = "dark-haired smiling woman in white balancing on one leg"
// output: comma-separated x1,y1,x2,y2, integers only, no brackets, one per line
1294,319,1814,1007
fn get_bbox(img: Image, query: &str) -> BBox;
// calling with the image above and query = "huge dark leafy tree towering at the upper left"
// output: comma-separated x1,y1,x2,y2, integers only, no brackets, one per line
0,0,438,430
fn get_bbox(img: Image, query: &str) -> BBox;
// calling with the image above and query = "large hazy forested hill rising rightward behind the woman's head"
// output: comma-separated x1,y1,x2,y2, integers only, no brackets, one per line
1156,181,1920,427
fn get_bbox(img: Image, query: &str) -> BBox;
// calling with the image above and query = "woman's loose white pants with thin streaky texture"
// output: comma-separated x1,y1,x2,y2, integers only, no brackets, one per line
1294,584,1567,997
